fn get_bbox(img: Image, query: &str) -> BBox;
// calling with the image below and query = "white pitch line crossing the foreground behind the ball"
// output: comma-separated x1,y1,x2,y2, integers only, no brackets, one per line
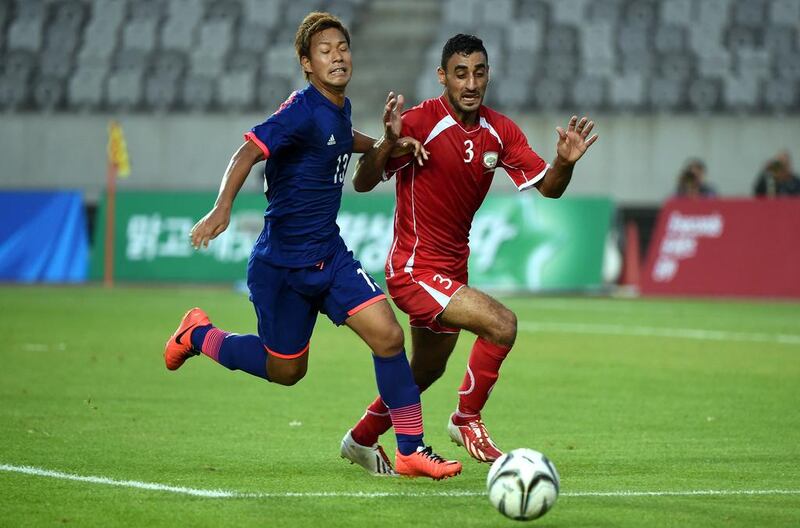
0,464,800,499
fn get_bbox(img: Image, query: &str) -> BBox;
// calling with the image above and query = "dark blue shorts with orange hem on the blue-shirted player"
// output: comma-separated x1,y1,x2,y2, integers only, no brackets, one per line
247,244,386,359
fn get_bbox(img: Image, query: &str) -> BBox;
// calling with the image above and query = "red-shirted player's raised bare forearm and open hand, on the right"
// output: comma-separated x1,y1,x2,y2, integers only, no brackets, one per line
536,116,597,198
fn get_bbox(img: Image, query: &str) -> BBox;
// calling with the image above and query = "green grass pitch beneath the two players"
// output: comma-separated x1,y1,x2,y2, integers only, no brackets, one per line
0,287,800,528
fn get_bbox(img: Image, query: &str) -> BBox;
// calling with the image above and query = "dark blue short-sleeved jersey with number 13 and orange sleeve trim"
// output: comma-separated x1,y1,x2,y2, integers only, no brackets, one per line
245,84,353,268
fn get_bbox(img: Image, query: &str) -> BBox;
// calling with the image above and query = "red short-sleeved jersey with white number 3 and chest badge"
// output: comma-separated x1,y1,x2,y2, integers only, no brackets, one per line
385,95,549,277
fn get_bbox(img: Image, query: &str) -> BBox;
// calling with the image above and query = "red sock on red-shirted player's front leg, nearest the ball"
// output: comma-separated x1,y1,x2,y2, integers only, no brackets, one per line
456,337,511,418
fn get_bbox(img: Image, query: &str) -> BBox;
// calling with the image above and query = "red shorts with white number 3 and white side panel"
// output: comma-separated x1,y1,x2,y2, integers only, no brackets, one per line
386,268,467,334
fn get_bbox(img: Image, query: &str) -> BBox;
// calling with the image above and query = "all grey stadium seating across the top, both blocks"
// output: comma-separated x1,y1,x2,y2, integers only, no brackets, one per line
0,0,800,114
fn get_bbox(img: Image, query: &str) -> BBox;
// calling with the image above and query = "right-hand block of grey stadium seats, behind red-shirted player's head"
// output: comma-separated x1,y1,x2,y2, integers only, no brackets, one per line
417,0,800,113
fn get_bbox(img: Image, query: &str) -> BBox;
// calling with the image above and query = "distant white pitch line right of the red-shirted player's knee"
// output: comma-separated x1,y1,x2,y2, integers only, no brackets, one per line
518,321,800,345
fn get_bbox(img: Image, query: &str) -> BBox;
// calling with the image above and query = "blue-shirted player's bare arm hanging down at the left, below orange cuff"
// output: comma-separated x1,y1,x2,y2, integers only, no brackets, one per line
190,141,264,249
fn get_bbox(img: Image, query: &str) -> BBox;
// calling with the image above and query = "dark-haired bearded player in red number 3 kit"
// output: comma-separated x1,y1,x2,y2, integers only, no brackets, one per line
342,34,597,471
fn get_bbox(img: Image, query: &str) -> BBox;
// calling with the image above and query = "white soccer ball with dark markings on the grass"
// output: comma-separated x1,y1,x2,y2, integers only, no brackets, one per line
486,448,559,521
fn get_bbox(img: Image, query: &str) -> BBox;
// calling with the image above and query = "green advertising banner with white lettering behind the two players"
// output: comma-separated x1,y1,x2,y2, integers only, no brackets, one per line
92,191,612,290
